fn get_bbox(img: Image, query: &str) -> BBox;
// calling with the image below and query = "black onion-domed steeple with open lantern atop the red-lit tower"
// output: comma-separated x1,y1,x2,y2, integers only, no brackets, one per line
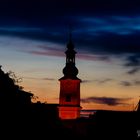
62,34,78,79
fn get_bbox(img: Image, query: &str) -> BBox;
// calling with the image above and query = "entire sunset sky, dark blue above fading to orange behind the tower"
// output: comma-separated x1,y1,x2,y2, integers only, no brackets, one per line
0,0,140,110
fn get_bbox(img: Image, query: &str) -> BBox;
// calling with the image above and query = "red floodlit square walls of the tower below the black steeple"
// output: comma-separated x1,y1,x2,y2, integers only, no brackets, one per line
59,79,81,119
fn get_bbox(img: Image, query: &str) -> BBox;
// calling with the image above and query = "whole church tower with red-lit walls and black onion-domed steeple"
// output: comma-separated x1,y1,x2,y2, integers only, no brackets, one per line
59,34,81,119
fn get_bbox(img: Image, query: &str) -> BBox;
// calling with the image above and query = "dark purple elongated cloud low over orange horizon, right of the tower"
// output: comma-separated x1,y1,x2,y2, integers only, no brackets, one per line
81,97,131,106
